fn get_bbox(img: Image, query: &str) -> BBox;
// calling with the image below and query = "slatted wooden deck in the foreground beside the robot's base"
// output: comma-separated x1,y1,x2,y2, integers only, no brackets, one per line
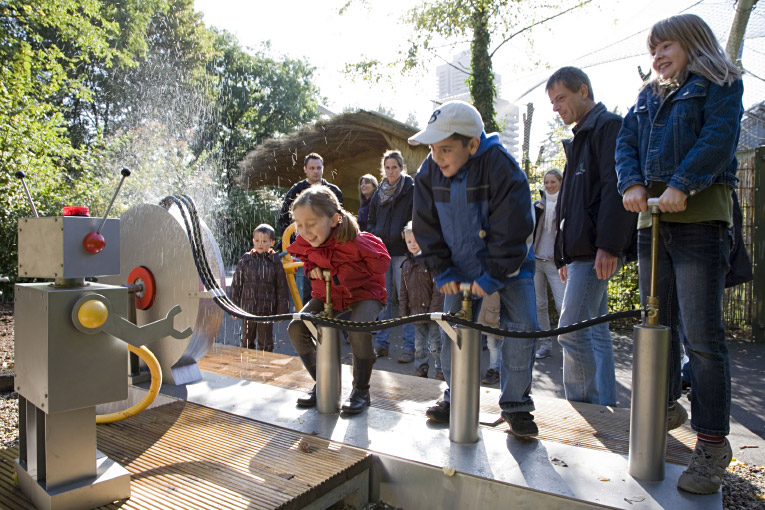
0,401,372,510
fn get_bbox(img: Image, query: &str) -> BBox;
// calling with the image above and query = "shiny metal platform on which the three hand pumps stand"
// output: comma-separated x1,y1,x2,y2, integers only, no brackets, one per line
157,371,722,510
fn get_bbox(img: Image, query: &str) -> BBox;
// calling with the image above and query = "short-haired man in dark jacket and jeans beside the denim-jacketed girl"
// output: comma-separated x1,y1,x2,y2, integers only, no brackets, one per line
545,67,637,406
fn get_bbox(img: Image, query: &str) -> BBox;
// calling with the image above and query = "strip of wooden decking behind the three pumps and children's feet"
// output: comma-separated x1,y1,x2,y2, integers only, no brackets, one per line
199,344,696,465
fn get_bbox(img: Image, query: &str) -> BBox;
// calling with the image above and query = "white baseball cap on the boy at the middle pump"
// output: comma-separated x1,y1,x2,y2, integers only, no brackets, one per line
409,101,483,145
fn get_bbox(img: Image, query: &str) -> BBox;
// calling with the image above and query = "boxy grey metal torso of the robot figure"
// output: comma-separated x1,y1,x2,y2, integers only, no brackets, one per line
15,283,127,413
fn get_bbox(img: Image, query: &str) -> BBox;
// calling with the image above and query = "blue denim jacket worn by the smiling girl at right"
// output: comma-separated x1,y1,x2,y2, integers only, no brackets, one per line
616,74,744,195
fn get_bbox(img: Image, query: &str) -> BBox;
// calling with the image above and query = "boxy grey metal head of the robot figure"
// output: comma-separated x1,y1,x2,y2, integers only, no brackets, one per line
18,216,120,278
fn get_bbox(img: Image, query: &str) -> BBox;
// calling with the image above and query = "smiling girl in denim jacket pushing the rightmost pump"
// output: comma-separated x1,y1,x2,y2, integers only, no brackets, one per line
616,14,743,494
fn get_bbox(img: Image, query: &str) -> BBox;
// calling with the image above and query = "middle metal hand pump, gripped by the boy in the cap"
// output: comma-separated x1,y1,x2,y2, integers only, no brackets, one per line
449,283,481,443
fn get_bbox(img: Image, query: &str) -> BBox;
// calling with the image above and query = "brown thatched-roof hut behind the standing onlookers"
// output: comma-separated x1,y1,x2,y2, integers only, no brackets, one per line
239,110,429,212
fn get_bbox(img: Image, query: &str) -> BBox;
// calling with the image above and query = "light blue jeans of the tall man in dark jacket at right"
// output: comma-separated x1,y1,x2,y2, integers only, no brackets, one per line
558,259,623,406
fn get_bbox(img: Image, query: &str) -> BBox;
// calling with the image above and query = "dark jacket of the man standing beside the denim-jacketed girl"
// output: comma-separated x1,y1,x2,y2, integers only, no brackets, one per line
555,103,637,268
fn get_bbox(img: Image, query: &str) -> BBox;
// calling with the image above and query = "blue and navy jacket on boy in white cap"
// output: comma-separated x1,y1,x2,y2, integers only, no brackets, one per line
412,133,534,293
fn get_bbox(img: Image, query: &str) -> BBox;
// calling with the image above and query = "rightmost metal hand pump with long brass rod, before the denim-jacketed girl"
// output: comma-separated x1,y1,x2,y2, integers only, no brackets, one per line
629,199,671,482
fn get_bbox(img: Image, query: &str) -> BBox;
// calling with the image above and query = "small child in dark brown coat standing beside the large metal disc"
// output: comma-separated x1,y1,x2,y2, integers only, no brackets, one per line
231,223,289,352
